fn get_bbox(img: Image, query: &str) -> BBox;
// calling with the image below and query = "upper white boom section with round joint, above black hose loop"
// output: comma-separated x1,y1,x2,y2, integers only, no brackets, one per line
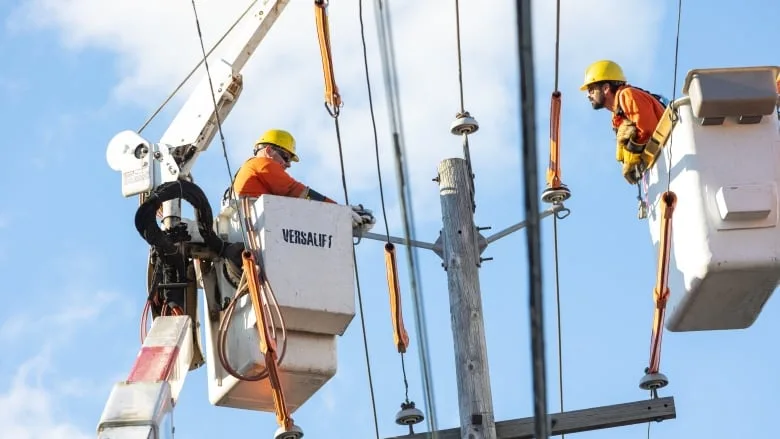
106,0,289,198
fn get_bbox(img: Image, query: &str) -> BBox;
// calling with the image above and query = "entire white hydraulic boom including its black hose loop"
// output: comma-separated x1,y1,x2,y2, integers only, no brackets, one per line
98,0,289,439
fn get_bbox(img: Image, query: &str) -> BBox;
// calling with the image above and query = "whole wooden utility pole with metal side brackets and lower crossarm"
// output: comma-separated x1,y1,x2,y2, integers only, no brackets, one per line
361,162,677,439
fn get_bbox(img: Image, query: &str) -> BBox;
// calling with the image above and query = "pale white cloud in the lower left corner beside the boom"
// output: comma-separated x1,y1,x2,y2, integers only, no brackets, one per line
0,272,131,439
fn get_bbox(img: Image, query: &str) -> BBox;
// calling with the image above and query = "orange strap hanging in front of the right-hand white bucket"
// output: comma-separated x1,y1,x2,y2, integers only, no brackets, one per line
647,191,677,373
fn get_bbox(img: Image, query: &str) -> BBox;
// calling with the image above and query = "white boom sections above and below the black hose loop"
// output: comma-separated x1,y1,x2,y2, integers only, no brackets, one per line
98,0,289,439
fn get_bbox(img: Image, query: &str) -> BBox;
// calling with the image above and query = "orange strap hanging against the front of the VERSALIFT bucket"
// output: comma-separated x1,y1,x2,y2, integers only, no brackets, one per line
241,251,293,430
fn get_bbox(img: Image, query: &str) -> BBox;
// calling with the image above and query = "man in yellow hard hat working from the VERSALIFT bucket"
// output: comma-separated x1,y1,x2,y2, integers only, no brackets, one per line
232,129,376,232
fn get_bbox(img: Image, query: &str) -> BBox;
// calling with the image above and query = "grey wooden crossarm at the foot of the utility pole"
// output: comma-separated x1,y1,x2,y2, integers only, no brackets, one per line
389,396,677,439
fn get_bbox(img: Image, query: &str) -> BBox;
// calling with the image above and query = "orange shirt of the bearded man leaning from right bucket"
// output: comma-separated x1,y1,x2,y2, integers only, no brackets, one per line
612,86,664,145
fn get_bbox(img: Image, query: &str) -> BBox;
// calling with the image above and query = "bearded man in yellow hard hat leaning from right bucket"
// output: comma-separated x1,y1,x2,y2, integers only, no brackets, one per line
580,60,668,184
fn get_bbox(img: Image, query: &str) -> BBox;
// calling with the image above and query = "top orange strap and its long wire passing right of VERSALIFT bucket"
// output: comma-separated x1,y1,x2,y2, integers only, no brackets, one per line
314,0,380,439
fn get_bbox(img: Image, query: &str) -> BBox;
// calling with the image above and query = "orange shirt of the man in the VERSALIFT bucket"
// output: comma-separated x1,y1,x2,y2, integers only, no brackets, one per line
233,157,307,197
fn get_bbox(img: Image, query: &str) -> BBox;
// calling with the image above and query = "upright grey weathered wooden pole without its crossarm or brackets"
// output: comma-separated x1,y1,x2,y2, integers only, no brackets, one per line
438,158,496,439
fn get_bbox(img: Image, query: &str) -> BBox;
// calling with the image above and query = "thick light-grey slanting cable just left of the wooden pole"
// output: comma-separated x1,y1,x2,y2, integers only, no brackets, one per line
374,0,438,439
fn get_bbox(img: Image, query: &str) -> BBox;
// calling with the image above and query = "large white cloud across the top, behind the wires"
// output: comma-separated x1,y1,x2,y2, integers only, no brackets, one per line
6,0,663,230
